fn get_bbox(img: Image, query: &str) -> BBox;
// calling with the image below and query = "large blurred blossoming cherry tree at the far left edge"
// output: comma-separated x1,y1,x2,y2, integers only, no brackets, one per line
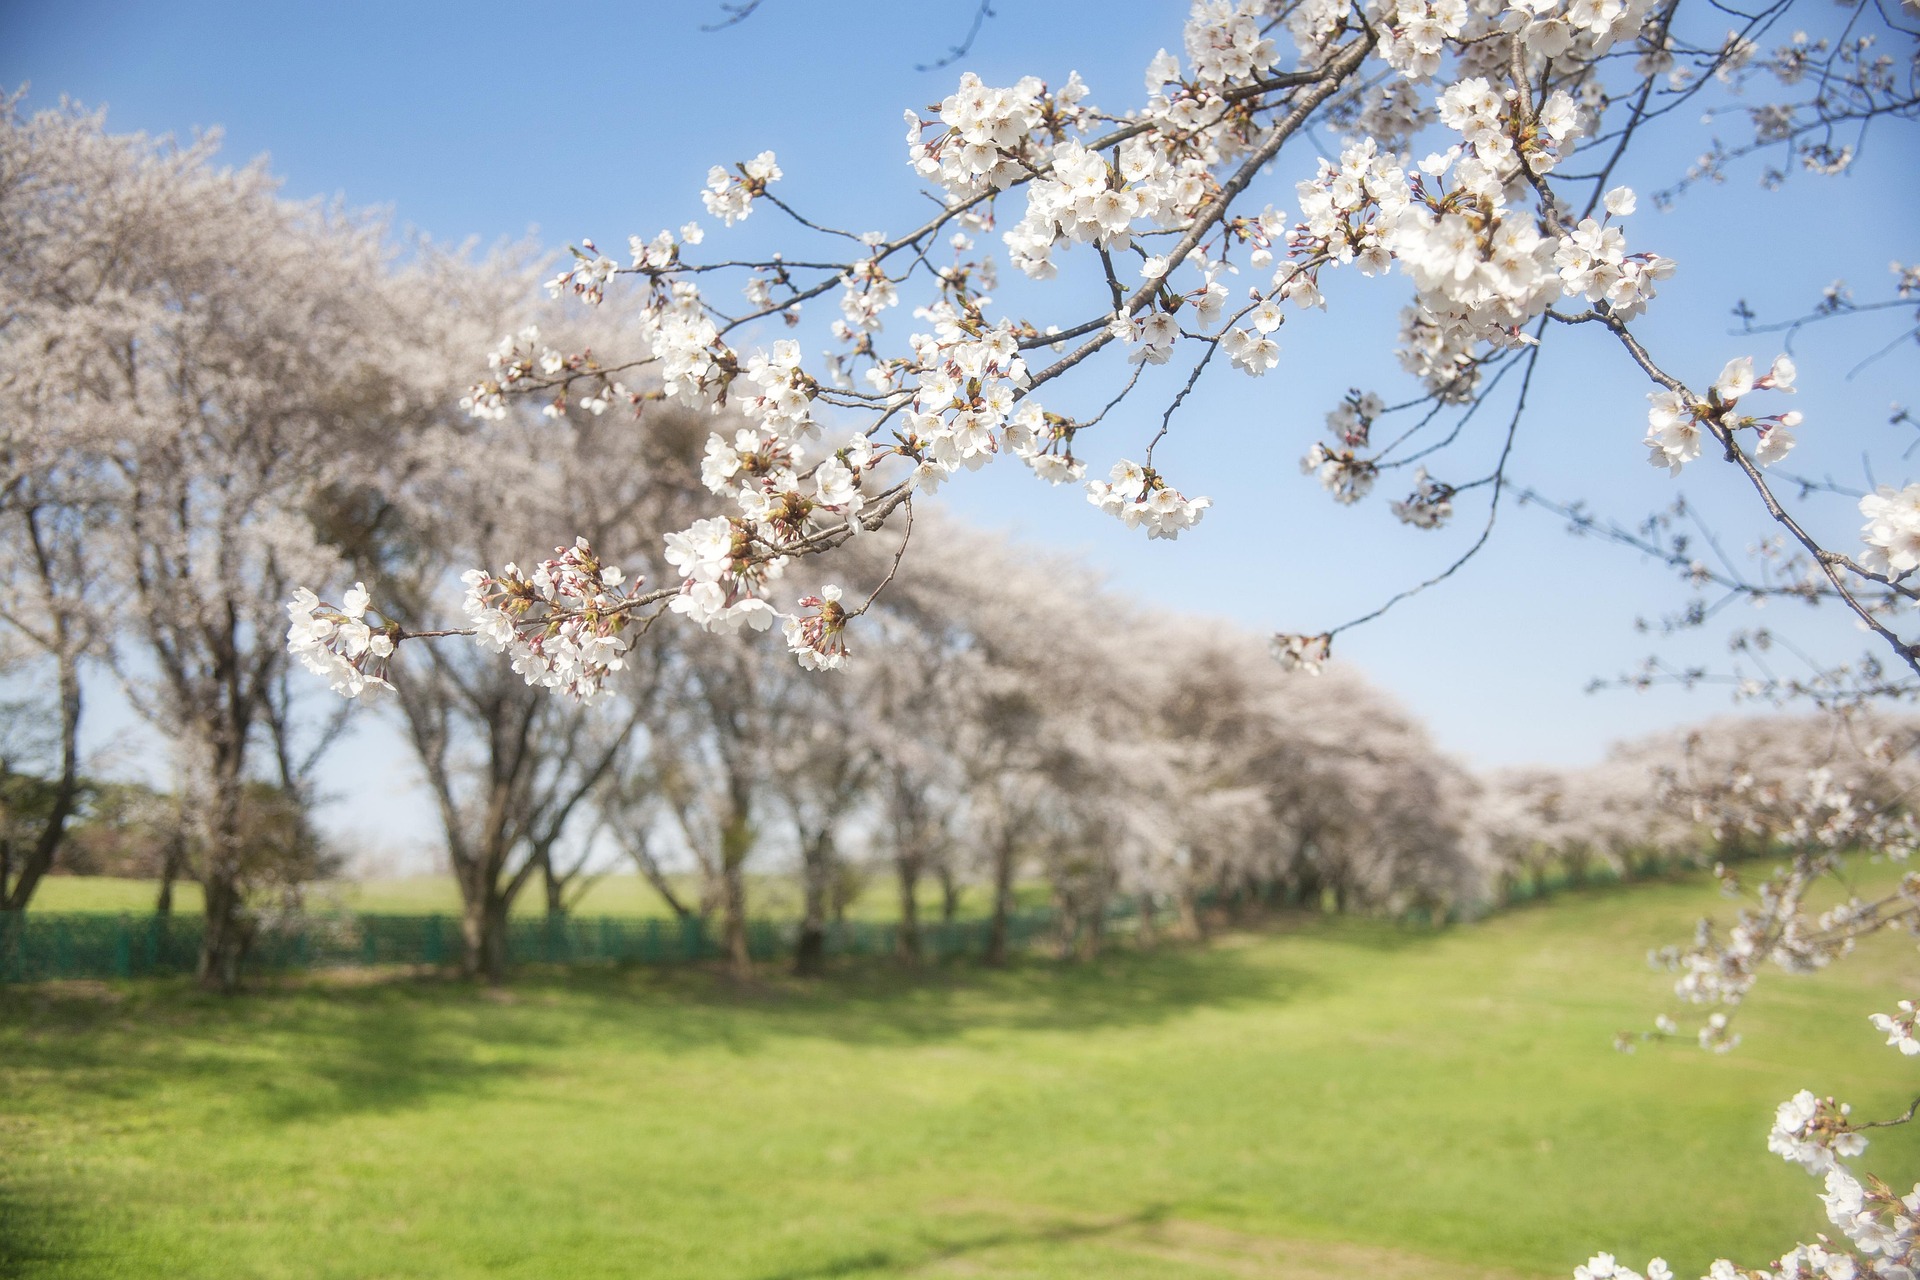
0,100,445,988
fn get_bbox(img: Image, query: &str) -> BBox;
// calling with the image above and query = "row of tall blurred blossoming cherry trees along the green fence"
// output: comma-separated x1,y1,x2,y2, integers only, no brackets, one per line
0,94,1480,988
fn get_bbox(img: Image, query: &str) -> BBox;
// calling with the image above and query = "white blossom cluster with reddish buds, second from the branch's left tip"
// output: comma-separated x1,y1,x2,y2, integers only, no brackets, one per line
461,537,639,702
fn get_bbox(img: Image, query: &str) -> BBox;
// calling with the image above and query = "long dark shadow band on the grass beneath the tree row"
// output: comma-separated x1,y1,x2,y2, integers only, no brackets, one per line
0,917,1436,1123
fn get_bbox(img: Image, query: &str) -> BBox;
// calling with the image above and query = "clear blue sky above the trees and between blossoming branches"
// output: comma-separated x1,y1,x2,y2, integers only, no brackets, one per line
0,0,1920,871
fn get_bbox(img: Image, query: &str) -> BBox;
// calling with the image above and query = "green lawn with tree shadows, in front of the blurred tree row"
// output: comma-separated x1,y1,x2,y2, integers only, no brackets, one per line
0,871,1920,1280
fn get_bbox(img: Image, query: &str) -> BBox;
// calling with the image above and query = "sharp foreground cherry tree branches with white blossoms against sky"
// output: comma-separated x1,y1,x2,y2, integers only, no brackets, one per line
274,0,1920,1276
